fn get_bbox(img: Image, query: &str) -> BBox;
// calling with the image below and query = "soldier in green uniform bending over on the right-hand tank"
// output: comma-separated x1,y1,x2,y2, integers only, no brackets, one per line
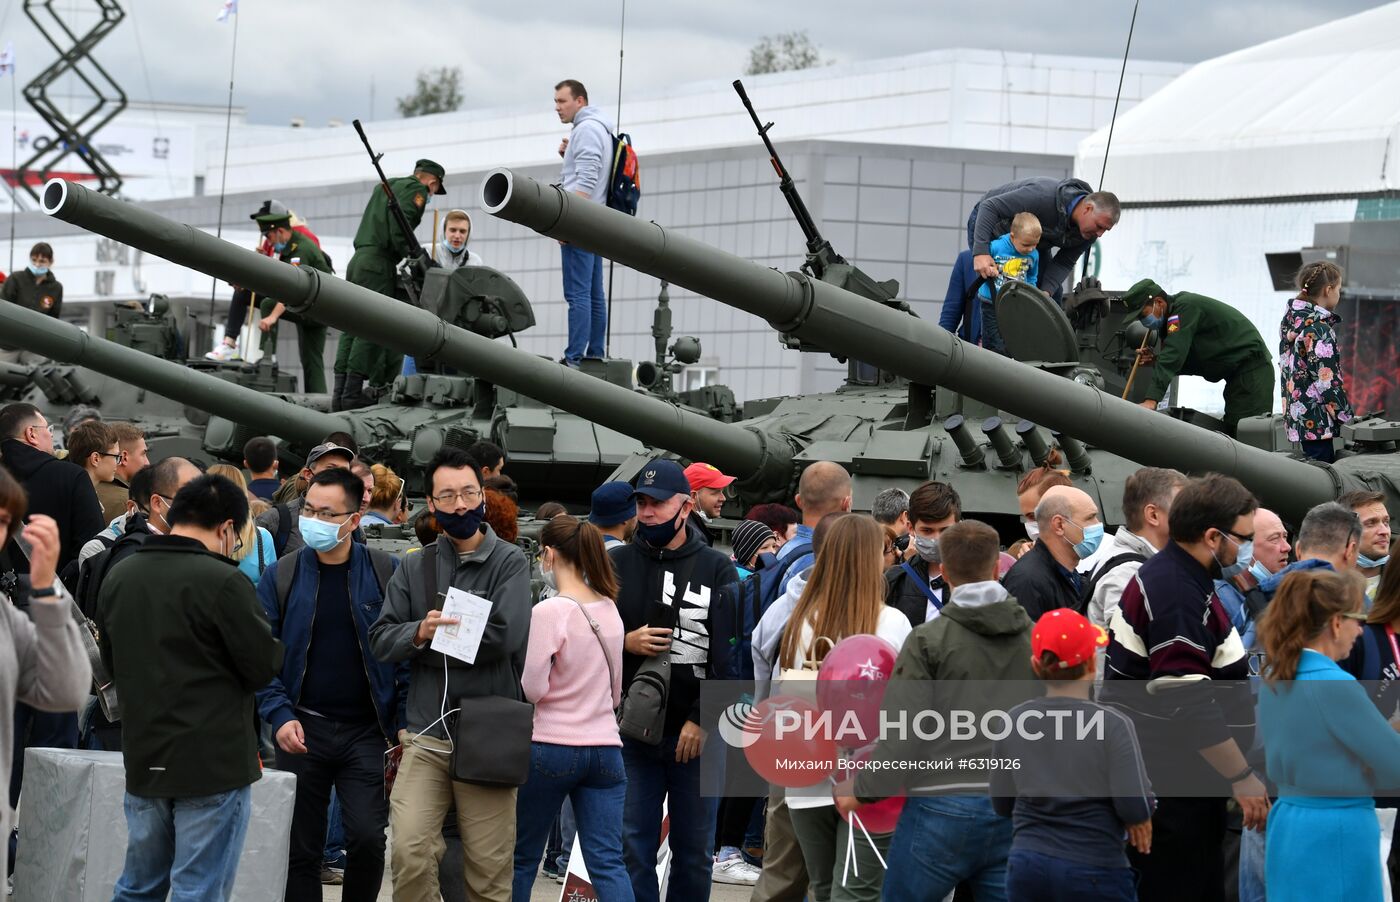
1123,279,1274,436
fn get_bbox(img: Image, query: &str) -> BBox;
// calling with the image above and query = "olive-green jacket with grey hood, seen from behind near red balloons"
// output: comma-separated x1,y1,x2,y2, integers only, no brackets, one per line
855,583,1039,801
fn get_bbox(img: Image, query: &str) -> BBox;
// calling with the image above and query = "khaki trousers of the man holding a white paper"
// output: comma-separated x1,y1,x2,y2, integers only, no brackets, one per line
389,733,515,902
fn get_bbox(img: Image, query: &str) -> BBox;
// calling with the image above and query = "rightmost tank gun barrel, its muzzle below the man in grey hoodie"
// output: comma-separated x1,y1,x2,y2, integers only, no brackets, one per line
482,169,1343,517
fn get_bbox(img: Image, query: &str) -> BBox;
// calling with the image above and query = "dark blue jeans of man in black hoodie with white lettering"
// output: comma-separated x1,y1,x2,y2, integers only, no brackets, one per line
627,735,721,902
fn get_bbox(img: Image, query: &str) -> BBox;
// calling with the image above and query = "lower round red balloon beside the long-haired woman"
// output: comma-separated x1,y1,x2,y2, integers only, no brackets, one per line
743,695,836,789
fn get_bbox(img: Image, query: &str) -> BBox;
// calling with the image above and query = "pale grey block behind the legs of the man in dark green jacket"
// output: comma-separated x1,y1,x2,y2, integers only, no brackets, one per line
14,748,297,902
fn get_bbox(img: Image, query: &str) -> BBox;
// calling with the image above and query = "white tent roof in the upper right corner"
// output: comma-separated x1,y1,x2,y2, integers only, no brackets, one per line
1075,3,1400,203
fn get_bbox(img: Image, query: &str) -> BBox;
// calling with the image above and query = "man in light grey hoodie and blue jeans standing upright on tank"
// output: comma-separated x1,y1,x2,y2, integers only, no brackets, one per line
554,78,613,368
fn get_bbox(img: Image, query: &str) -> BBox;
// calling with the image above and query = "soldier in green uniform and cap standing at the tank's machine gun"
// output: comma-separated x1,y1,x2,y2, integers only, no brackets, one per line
330,160,447,410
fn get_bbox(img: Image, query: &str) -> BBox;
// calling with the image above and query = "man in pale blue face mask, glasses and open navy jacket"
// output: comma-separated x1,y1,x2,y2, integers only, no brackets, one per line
258,466,409,902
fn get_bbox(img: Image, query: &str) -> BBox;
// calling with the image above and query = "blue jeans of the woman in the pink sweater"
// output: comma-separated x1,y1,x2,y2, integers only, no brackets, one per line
511,742,632,902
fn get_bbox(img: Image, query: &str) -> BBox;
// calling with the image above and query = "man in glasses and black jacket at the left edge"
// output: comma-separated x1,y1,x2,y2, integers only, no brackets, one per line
0,402,106,571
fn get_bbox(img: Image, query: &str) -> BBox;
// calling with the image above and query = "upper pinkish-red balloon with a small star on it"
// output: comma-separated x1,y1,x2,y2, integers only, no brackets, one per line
816,634,899,748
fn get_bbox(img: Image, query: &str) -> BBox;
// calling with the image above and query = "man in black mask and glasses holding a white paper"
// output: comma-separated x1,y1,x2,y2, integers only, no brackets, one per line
366,448,531,902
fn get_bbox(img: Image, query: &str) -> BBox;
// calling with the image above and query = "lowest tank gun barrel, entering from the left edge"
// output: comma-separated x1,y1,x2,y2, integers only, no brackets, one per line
0,299,350,445
